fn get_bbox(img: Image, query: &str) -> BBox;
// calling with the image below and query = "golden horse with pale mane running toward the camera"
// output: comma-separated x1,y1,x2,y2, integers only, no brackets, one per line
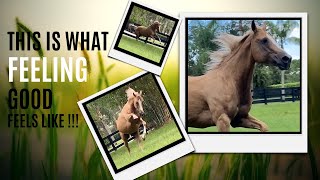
116,88,147,153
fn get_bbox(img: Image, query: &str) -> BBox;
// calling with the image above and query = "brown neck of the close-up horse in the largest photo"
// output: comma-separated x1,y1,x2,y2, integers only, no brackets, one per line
210,38,255,98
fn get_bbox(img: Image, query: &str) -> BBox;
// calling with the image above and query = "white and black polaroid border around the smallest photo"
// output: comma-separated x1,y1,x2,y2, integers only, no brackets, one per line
108,0,181,76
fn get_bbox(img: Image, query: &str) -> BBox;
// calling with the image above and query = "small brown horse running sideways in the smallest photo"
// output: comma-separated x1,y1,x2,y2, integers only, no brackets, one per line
135,21,161,43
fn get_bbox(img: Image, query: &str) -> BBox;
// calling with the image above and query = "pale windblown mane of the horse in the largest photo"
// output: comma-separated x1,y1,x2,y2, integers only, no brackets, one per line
206,31,253,72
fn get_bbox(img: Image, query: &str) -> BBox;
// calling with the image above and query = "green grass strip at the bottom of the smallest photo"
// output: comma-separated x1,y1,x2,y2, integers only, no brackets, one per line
119,35,163,63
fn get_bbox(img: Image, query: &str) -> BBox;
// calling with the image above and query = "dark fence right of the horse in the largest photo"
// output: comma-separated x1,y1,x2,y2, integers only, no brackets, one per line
252,87,301,104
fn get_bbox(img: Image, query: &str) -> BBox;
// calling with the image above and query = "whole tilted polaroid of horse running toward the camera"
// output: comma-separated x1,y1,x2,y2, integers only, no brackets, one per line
78,72,193,178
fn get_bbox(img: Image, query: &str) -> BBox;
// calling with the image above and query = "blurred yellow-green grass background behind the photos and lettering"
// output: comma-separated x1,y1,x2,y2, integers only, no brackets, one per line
0,0,320,180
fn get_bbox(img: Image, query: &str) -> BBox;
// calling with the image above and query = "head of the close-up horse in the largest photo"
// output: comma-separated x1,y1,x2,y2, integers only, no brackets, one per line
251,21,292,70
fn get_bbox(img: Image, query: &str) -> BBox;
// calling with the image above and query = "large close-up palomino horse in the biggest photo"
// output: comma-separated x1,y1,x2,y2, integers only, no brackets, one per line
187,21,291,132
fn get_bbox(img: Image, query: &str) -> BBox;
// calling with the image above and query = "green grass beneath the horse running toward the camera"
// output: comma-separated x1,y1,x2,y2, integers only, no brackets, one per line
111,121,182,169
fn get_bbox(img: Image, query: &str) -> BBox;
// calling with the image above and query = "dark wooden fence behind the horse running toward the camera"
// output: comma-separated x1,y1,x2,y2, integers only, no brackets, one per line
103,126,149,153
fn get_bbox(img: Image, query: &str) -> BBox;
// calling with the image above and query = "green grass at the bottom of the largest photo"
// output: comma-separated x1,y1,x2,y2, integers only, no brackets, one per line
188,101,300,132
